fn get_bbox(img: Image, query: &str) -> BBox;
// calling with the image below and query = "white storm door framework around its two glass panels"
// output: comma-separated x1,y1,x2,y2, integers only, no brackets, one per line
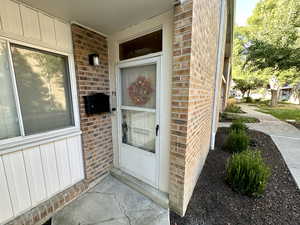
116,53,162,188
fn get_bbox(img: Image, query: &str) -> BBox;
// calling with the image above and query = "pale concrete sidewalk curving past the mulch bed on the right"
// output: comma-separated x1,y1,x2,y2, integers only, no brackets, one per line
219,105,300,188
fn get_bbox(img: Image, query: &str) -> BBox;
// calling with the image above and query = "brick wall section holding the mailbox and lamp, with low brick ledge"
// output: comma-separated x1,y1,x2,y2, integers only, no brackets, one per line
5,25,113,225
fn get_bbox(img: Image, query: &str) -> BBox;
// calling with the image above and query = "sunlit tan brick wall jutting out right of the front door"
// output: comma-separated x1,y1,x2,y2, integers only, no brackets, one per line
170,0,221,215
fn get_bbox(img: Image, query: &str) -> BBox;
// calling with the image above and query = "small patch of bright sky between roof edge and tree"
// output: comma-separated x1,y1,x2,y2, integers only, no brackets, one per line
235,0,260,26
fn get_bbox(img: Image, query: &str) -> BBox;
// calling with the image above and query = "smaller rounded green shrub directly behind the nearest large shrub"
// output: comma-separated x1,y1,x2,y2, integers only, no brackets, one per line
223,131,249,153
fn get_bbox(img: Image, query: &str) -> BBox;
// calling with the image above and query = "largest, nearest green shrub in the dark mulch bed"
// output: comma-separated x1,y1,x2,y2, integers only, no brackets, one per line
226,150,270,196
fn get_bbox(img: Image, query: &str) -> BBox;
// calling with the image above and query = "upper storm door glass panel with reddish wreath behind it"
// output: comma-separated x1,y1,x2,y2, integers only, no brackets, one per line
121,64,156,108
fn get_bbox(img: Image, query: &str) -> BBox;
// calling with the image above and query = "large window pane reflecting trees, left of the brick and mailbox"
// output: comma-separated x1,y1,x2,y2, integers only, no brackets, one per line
11,45,74,135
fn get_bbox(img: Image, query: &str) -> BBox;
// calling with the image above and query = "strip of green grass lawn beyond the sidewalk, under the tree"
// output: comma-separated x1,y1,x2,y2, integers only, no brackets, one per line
255,103,300,122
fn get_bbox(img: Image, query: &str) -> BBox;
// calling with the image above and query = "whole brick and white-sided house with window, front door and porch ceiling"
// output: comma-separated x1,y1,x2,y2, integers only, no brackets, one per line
0,0,234,225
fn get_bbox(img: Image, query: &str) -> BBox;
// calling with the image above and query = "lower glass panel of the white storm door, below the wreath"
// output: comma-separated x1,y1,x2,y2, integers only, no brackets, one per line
122,110,155,153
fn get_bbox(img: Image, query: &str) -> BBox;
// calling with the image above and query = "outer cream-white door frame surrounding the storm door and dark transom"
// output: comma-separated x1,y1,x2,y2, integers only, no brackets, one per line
108,9,174,193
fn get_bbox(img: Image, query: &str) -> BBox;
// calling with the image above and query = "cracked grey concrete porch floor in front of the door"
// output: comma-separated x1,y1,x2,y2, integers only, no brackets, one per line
52,176,170,225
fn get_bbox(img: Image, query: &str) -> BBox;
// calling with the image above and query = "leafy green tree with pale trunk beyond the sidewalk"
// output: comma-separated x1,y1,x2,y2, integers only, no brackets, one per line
238,0,300,104
